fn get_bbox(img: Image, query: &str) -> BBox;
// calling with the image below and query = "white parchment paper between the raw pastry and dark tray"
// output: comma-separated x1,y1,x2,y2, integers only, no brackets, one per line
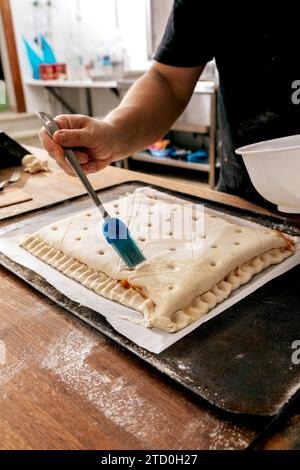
0,190,300,354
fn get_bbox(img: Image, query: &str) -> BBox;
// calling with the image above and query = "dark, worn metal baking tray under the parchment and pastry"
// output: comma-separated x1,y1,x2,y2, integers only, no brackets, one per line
0,182,300,416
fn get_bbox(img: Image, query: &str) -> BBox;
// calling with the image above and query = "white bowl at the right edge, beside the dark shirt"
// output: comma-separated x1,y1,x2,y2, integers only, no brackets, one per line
236,135,300,214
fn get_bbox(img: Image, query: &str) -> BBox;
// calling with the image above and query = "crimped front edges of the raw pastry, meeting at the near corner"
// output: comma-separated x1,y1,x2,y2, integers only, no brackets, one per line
20,235,293,333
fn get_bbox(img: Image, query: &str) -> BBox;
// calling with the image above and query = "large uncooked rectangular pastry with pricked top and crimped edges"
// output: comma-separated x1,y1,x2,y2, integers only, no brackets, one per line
21,191,294,332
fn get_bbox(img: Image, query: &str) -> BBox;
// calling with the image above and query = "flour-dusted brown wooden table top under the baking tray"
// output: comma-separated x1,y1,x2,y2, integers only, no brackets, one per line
0,149,298,450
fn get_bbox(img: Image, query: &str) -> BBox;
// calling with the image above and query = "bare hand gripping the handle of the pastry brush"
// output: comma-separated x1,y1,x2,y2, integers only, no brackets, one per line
40,114,116,176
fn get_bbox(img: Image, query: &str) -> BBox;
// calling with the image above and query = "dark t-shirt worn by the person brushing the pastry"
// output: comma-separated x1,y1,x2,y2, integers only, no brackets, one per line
154,0,300,201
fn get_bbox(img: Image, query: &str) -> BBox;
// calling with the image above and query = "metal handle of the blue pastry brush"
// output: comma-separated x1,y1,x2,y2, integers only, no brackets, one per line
36,111,109,219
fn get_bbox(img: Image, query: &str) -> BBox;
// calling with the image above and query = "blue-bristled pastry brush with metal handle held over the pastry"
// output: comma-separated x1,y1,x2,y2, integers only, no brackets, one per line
36,111,145,268
